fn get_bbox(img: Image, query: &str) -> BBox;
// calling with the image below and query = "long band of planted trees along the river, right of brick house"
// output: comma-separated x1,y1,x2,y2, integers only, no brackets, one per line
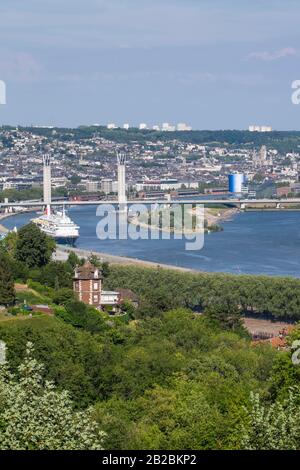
105,265,300,320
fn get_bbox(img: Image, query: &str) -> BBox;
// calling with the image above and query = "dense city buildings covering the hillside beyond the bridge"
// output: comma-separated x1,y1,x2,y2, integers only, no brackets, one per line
0,123,300,206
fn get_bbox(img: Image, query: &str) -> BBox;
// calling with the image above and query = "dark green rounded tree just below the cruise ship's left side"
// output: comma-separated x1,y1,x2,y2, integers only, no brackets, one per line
15,222,55,268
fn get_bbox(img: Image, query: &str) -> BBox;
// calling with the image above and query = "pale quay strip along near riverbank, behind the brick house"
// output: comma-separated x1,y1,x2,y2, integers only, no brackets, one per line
54,245,199,273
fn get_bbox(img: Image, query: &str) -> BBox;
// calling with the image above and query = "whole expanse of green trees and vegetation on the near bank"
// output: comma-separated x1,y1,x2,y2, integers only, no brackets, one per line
0,224,300,450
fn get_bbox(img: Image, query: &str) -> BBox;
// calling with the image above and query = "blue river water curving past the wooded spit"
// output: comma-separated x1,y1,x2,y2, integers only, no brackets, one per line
2,206,300,277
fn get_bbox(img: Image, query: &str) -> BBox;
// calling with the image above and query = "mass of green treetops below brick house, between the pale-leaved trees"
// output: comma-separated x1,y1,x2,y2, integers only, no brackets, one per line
0,303,278,449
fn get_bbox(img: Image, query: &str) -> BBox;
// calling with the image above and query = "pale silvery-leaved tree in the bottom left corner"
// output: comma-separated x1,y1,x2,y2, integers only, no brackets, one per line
0,343,104,450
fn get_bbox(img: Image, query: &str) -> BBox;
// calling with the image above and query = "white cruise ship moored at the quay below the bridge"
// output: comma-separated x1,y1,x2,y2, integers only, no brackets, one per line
32,207,80,245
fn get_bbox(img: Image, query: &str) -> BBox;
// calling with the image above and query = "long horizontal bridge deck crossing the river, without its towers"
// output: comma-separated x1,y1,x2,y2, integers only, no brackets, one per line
0,198,300,209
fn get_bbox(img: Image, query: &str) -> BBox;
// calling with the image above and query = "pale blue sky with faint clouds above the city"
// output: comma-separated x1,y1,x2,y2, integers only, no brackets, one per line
0,0,300,130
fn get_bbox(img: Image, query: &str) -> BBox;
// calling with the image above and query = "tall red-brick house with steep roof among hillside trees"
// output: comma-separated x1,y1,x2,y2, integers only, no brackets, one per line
73,261,102,307
